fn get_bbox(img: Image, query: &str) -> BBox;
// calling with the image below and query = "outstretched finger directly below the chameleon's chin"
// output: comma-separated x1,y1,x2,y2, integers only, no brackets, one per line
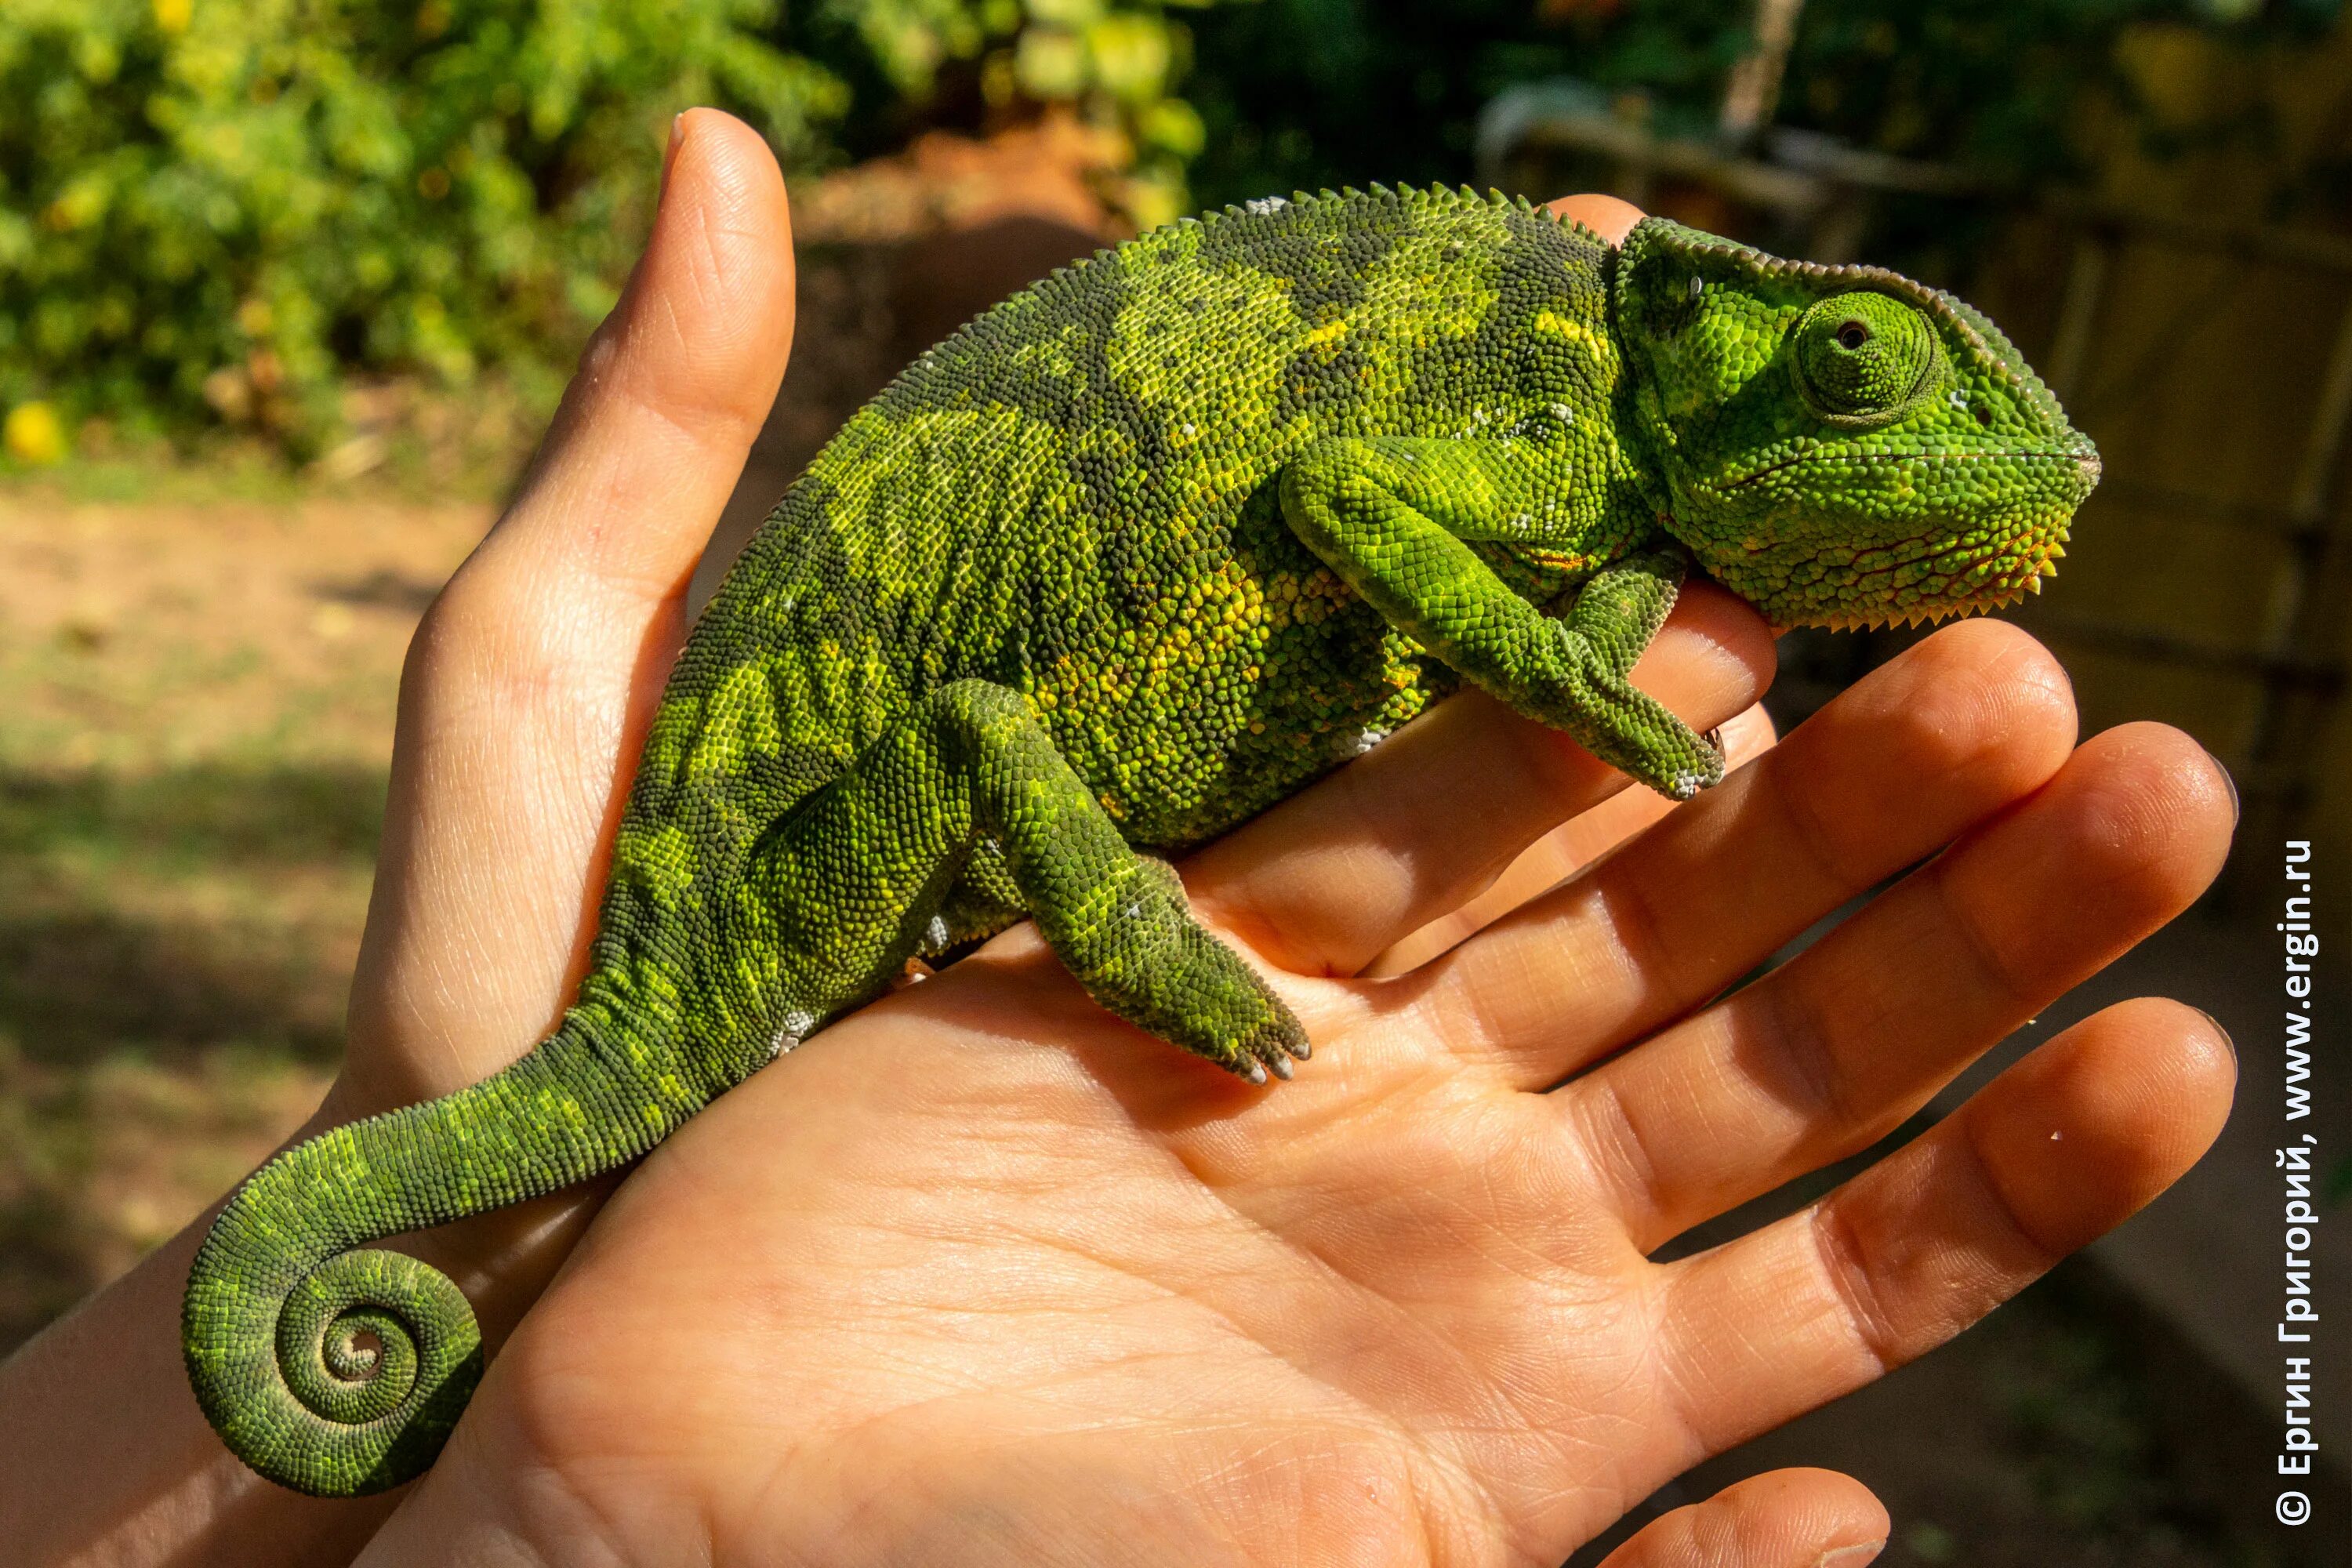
1416,621,2074,1088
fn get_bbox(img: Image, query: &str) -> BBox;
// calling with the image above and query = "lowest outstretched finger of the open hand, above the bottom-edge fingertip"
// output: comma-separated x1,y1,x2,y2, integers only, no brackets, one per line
1661,999,2237,1453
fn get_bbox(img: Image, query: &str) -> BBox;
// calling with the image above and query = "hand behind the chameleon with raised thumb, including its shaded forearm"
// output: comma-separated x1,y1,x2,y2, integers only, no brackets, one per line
0,111,793,1568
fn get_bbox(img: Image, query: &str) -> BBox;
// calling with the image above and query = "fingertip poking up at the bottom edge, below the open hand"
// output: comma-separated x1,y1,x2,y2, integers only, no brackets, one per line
1602,1469,1886,1568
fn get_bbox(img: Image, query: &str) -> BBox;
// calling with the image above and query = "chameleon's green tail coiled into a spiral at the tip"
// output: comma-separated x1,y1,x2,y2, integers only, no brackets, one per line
181,1011,715,1497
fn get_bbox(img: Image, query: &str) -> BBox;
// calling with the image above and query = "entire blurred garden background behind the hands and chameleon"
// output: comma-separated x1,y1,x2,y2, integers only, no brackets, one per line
0,0,2352,1568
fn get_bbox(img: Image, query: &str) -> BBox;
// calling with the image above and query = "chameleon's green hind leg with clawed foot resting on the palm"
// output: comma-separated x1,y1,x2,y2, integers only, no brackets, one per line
729,680,1308,1083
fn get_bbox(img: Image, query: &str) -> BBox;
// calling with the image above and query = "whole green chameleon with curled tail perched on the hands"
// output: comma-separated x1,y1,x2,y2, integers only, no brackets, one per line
183,186,2098,1495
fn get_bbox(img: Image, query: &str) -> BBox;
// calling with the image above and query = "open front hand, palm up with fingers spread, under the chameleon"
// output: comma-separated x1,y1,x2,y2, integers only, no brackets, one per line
369,564,2232,1568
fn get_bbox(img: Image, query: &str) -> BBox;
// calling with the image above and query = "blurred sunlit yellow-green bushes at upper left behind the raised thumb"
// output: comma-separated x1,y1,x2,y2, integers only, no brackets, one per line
0,0,1232,461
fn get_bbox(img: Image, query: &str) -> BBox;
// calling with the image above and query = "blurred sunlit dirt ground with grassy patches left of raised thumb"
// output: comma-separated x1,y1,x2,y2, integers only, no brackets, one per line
0,492,489,1349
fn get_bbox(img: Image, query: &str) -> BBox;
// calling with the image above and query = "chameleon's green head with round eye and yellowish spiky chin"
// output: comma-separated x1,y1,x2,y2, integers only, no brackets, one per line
1611,219,2098,628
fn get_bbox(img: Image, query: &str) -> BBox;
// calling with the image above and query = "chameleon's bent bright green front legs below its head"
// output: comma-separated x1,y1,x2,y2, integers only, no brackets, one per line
1282,437,1724,799
